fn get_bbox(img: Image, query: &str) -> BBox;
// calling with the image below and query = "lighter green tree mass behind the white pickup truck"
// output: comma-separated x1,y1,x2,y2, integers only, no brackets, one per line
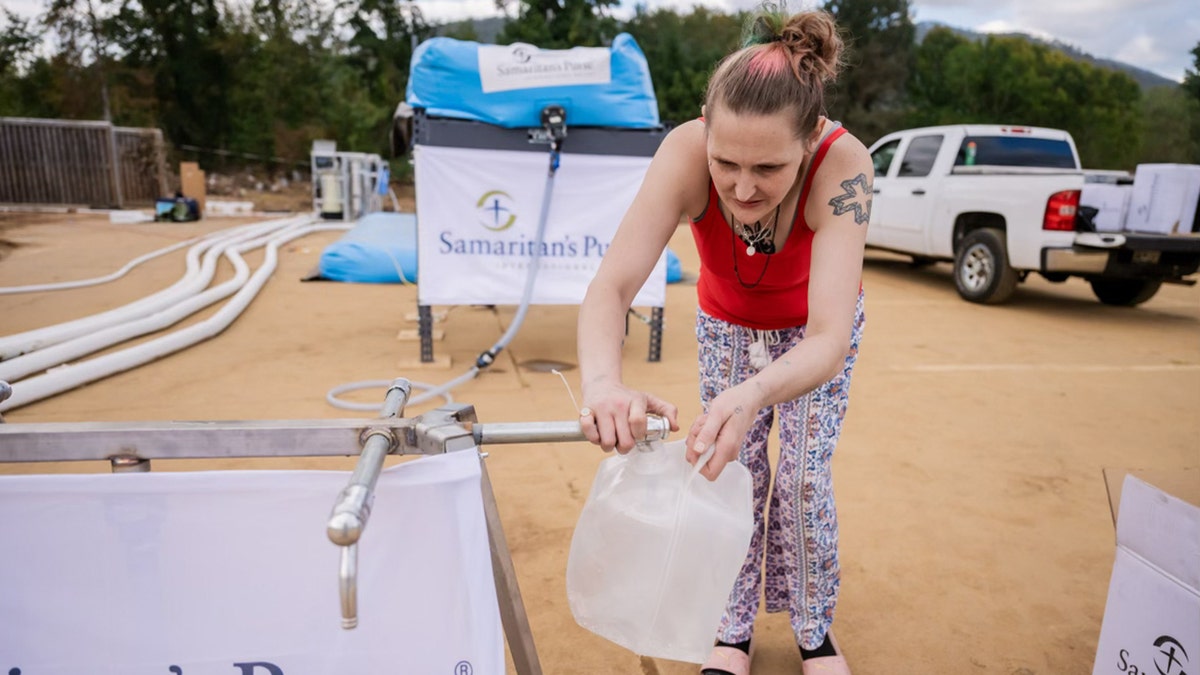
907,28,1141,168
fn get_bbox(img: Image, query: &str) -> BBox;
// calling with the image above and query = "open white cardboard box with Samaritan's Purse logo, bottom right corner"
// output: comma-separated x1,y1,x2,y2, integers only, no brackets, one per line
1092,468,1200,675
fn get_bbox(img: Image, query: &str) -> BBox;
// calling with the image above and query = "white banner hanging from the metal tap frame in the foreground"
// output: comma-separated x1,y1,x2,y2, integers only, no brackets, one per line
0,450,504,675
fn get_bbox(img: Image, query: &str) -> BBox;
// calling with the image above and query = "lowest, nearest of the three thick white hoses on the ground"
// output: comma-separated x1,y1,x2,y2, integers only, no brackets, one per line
0,216,348,412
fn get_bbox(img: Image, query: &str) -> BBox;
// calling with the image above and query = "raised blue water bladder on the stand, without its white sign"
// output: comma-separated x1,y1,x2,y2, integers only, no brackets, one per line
406,32,661,129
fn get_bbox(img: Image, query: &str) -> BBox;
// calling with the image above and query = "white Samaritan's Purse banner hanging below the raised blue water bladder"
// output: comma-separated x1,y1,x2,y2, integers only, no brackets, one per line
414,147,666,306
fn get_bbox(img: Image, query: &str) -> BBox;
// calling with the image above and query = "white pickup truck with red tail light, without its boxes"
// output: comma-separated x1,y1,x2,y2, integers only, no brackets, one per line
866,125,1200,305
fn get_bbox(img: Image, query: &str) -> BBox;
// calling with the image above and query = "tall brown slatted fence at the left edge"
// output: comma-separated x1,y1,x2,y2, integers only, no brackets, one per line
0,118,167,208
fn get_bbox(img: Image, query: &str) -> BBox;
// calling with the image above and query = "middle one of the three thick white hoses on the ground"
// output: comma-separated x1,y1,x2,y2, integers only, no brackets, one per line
0,219,321,383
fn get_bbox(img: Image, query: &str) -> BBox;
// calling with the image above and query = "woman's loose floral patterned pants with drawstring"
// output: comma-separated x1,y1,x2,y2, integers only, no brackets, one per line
696,294,864,649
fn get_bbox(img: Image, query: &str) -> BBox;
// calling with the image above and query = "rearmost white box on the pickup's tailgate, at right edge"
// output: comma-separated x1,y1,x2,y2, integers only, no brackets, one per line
1126,165,1200,234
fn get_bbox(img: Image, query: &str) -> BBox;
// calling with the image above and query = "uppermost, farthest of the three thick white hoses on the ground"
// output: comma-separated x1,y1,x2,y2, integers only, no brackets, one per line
0,215,300,360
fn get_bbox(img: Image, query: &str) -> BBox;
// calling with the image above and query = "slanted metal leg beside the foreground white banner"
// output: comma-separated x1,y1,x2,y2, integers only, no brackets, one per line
480,459,541,675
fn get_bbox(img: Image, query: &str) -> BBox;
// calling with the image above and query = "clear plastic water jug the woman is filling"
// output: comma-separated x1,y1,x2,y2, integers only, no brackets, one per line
566,441,754,663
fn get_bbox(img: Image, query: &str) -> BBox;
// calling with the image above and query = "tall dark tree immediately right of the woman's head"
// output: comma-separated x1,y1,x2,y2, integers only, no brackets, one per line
824,0,914,143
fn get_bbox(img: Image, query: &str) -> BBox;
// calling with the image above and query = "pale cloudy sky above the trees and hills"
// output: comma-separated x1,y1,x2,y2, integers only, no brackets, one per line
0,0,1200,82
